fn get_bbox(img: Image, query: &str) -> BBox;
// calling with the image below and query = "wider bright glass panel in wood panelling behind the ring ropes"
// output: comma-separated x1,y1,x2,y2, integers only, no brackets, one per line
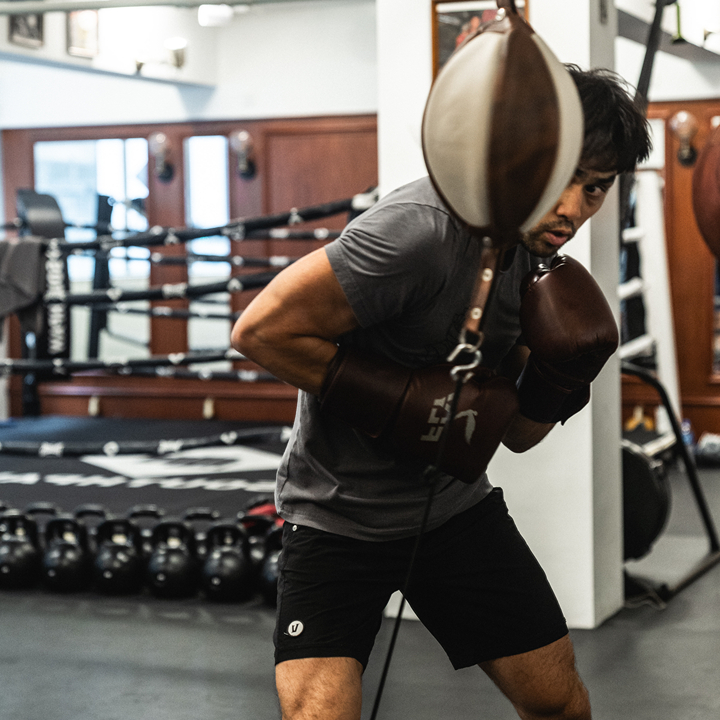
33,138,150,360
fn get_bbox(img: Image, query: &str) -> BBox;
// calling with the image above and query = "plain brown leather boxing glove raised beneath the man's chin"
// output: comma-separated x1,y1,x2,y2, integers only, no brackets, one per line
518,256,618,423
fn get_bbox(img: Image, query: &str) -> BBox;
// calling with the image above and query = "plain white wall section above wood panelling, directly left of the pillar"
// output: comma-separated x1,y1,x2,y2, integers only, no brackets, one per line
203,0,377,118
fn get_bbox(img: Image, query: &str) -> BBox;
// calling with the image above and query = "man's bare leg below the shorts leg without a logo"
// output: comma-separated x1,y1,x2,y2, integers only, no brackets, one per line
480,635,590,720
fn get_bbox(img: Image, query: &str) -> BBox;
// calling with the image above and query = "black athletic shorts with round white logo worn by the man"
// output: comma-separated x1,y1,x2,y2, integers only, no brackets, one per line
274,488,568,669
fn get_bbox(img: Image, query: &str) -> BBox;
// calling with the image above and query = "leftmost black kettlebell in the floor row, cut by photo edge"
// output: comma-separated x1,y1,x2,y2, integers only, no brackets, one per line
0,510,41,589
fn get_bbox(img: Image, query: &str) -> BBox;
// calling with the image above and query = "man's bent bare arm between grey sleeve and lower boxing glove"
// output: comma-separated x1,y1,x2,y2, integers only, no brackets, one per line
231,248,358,395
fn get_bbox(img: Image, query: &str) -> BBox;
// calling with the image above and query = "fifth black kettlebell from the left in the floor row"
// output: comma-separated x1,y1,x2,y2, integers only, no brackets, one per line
201,522,256,602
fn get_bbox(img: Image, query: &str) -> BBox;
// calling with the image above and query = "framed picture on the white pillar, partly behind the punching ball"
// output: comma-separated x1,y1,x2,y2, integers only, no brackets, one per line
432,0,528,76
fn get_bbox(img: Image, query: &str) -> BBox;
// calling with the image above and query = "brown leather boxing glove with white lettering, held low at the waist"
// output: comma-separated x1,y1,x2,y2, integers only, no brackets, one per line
320,349,517,483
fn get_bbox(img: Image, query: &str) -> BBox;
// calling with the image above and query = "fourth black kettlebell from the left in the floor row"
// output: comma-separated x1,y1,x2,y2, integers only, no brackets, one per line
146,520,200,598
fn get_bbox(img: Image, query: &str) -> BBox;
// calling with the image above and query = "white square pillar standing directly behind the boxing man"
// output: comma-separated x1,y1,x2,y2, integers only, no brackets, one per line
377,0,623,628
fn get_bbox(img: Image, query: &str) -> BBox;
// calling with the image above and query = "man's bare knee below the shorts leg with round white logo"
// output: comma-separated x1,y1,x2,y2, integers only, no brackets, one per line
275,657,362,720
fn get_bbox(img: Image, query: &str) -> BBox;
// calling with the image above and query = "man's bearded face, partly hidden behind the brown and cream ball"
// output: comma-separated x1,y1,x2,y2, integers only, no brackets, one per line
521,167,616,257
